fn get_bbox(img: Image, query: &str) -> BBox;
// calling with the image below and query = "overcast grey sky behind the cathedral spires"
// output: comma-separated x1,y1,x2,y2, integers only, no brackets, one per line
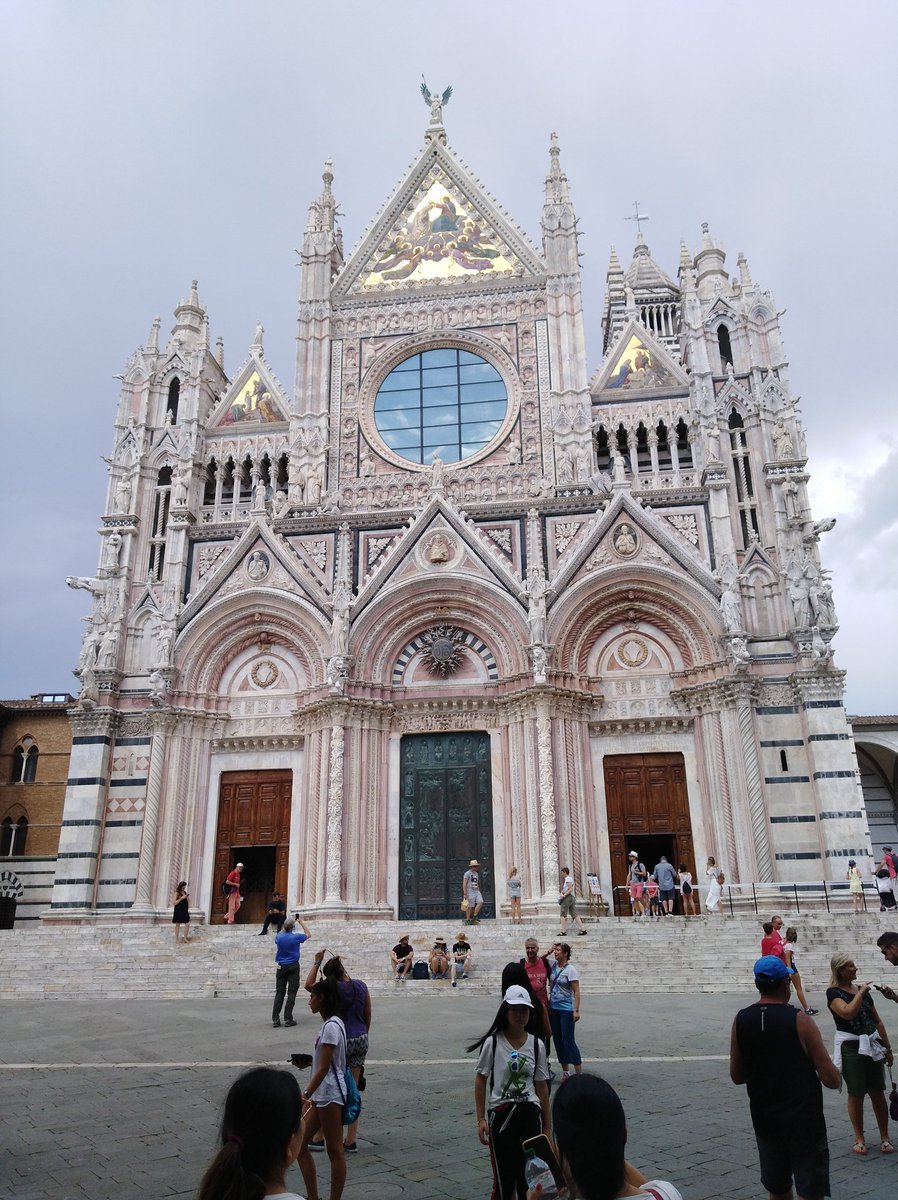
0,0,898,714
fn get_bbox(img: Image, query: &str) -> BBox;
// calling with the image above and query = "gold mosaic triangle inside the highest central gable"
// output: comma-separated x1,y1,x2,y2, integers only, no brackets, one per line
353,174,529,292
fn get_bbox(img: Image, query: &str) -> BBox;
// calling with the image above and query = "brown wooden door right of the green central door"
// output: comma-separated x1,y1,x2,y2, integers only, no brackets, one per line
603,754,695,902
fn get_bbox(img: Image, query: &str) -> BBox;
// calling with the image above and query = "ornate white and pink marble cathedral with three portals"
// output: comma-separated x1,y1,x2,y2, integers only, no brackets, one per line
52,94,870,923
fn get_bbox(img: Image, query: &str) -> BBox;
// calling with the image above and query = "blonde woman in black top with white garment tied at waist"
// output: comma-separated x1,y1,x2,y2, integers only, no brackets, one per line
826,954,894,1154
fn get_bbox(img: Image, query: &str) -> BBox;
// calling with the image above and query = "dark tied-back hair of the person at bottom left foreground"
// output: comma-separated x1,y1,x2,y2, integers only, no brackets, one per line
197,1067,303,1200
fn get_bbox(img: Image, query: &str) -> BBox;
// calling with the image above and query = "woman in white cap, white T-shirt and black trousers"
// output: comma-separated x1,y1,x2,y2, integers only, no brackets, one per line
468,984,552,1200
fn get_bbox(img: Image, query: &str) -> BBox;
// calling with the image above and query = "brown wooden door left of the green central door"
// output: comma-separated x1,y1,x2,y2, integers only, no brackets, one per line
211,770,294,924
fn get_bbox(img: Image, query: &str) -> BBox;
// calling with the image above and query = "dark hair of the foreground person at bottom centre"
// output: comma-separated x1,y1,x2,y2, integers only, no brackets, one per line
552,1075,627,1200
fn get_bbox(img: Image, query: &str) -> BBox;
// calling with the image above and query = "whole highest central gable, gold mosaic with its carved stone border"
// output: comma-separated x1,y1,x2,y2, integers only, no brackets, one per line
335,143,545,298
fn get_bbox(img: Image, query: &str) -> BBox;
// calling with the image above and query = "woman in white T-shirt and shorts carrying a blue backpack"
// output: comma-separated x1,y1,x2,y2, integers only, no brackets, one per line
298,979,347,1200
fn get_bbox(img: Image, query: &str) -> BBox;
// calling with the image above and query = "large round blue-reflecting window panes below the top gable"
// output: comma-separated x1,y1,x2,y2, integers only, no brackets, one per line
375,348,508,463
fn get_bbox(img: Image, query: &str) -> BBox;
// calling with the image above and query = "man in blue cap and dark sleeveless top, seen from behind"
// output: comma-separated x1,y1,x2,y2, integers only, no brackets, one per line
730,954,842,1200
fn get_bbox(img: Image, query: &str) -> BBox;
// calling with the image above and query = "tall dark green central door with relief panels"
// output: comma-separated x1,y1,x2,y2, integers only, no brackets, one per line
399,733,496,920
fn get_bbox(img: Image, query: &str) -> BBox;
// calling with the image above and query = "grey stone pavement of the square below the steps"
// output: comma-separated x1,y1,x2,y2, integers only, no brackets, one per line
0,973,898,1200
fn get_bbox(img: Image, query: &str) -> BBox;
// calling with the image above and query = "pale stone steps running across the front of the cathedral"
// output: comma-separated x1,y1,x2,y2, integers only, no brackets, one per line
0,911,898,1007
